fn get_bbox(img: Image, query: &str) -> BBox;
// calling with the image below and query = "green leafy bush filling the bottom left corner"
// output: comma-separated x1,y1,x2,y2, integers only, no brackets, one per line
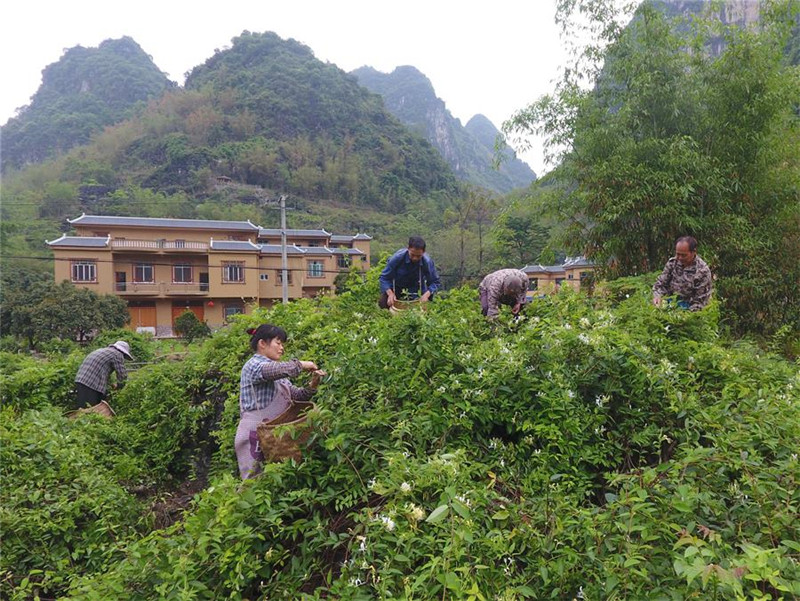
0,407,148,599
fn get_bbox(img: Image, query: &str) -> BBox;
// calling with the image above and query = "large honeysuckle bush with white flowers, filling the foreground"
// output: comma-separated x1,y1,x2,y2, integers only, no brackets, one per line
1,273,800,600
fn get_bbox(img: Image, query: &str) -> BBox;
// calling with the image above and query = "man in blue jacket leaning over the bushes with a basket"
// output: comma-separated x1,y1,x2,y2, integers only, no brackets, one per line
378,236,442,309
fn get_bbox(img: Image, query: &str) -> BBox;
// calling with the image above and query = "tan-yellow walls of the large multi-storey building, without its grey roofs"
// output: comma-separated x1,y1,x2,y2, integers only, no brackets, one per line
51,218,370,336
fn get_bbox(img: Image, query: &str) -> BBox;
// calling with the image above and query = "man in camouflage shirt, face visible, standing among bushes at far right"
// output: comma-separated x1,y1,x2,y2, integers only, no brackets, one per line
653,236,711,311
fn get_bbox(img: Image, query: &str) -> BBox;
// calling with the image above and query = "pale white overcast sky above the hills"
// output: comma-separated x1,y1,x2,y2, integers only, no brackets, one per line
0,0,564,175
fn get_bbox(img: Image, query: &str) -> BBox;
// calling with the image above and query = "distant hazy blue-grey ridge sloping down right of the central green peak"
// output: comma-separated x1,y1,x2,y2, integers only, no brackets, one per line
353,66,536,194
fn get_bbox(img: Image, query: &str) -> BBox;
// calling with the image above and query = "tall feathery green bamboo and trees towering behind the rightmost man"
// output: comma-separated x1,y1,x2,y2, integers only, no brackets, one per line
507,0,800,334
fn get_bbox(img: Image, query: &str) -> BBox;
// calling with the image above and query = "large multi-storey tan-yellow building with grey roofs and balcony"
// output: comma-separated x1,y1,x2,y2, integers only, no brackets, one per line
47,214,372,337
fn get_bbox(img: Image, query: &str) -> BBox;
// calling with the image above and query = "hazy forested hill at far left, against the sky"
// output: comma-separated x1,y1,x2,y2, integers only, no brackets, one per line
0,37,175,172
